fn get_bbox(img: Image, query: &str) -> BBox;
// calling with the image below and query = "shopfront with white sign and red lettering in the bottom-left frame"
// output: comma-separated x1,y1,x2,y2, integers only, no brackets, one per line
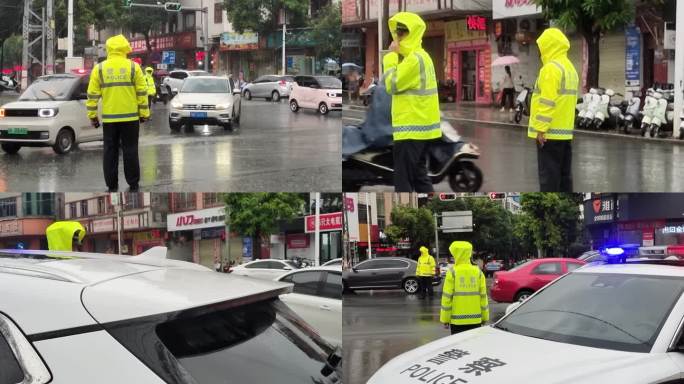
166,207,246,269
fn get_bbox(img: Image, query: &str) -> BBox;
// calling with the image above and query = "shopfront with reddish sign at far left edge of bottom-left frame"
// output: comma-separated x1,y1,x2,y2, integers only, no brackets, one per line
0,218,54,249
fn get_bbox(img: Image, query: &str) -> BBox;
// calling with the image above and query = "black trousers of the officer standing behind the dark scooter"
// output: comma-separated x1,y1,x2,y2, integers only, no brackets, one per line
394,140,434,192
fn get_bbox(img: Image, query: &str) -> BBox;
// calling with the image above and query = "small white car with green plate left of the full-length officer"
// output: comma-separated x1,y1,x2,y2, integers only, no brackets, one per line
0,70,102,154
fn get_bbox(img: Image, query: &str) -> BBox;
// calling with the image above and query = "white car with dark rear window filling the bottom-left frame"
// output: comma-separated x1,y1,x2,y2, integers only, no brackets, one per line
0,247,341,384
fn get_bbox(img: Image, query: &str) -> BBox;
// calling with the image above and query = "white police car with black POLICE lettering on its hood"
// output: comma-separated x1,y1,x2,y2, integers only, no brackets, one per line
368,249,684,384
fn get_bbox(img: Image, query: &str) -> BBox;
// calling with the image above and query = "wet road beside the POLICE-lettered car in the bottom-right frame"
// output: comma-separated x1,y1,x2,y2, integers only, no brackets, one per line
342,279,509,384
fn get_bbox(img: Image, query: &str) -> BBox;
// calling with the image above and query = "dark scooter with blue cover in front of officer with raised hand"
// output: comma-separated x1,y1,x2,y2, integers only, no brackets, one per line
342,84,483,192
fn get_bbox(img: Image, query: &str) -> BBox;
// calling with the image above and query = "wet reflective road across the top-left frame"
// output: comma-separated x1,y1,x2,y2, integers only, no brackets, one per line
0,94,342,192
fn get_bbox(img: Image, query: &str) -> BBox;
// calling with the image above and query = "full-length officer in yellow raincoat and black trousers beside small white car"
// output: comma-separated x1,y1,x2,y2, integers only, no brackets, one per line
86,35,150,192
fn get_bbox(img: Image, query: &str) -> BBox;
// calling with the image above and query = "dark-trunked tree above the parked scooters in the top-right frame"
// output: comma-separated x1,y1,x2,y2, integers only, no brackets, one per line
533,0,663,87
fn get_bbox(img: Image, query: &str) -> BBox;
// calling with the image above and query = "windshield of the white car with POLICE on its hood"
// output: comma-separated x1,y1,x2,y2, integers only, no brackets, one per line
496,273,684,352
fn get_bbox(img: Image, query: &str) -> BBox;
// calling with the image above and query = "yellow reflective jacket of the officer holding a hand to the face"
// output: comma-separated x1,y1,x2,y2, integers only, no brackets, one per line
382,12,442,140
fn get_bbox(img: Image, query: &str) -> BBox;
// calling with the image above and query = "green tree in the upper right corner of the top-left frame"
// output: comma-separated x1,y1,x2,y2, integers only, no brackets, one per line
311,2,342,62
